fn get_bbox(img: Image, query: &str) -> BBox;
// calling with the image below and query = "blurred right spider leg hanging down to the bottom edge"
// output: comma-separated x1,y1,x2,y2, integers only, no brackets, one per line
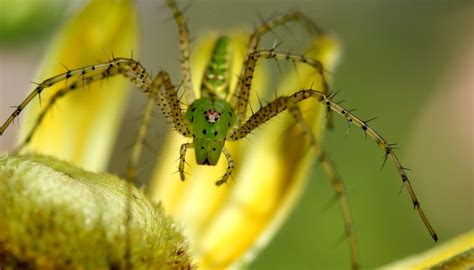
285,97,360,269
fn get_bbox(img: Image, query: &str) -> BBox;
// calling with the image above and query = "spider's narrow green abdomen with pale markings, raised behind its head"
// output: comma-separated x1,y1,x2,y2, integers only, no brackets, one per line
201,36,232,98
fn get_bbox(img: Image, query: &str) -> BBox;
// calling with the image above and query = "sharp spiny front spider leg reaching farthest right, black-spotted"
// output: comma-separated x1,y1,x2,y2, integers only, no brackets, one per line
229,89,438,241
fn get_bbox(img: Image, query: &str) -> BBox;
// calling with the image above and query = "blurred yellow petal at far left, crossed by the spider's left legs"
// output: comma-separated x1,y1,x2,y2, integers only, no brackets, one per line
19,0,138,171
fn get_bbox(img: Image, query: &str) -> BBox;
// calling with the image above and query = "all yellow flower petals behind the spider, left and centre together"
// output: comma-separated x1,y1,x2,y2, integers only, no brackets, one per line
4,0,339,269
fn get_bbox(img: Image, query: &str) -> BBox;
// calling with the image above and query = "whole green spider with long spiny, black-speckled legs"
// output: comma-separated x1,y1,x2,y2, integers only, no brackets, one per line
0,0,437,268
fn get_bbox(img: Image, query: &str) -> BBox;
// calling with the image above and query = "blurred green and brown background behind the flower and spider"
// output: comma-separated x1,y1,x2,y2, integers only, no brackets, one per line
0,0,474,269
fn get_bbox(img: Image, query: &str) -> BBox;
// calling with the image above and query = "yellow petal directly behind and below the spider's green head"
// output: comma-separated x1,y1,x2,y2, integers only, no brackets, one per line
149,32,256,242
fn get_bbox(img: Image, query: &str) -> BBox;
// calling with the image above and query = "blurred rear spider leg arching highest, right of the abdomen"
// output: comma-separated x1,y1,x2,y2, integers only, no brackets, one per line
231,11,323,126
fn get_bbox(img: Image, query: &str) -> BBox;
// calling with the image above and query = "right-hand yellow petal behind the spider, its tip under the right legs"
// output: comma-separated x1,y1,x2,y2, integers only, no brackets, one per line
198,34,339,268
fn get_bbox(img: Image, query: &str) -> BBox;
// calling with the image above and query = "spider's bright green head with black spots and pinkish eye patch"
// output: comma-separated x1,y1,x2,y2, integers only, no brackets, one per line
186,97,236,165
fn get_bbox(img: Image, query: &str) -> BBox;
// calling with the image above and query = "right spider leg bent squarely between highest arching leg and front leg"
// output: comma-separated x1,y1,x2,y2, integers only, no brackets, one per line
231,50,329,126
